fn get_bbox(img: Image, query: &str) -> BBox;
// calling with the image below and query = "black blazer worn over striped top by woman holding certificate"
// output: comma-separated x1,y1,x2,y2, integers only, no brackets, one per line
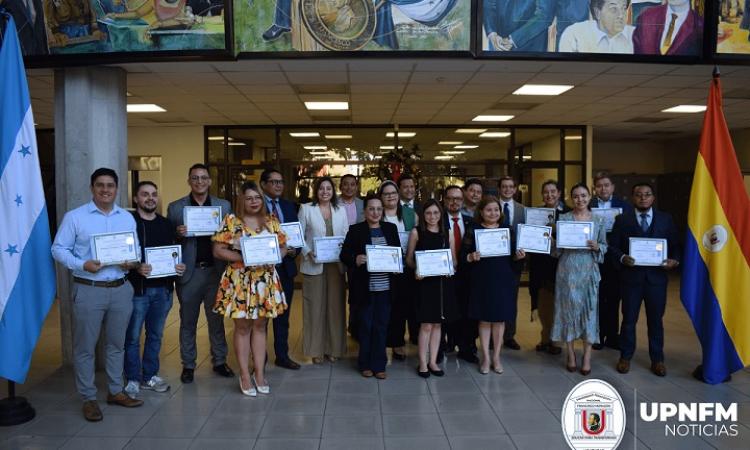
340,222,401,305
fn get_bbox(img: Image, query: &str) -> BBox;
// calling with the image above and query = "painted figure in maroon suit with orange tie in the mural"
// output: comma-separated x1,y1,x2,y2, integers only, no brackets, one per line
633,0,703,55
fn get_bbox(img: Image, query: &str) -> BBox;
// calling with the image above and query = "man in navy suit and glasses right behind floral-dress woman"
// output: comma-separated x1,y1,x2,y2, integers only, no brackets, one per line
260,169,300,370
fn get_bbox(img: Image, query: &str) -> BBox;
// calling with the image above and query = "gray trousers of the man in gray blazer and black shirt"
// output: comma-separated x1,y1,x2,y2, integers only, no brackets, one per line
177,267,228,369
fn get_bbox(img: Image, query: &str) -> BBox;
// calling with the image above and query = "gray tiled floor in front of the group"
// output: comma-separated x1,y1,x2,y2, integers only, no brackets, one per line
0,283,750,450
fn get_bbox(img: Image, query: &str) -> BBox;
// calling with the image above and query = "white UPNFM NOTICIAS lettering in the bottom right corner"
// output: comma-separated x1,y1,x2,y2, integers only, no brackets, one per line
640,402,739,437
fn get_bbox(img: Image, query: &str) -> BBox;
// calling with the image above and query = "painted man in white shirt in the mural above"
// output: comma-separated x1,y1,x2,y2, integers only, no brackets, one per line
559,0,635,54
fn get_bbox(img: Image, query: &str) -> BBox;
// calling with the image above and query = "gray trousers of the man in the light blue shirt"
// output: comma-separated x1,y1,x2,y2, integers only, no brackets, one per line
73,281,133,401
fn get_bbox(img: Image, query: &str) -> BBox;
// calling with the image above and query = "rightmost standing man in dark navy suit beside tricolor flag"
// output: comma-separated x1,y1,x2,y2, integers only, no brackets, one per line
609,183,680,377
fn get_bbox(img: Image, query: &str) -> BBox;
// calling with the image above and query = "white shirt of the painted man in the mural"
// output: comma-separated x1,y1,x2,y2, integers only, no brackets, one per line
559,20,635,54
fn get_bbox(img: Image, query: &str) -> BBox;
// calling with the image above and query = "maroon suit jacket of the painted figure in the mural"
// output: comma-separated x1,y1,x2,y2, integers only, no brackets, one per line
633,5,703,55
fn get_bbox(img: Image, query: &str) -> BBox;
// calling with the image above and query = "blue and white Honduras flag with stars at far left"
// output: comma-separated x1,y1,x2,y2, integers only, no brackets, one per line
0,12,55,383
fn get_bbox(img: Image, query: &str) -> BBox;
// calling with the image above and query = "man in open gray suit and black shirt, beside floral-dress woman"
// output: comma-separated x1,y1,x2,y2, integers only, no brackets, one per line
167,164,234,383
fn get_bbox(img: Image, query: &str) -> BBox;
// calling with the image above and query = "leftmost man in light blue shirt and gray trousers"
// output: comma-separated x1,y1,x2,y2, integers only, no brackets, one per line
52,168,143,422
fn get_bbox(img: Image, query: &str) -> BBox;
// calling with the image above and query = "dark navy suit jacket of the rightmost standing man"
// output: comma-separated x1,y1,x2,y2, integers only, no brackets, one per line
607,208,681,286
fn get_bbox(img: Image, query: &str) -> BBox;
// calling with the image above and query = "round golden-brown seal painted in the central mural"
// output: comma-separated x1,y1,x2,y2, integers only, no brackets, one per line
300,0,377,51
